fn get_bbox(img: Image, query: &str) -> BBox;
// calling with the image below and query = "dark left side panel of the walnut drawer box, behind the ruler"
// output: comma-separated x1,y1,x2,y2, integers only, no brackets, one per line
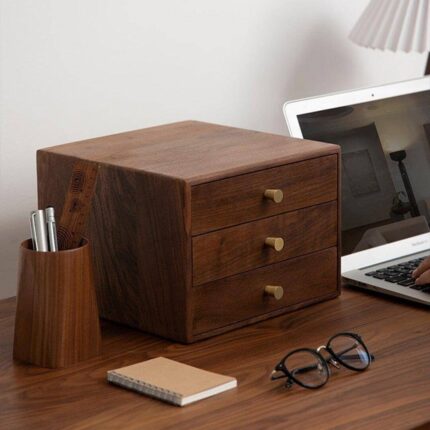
38,151,191,342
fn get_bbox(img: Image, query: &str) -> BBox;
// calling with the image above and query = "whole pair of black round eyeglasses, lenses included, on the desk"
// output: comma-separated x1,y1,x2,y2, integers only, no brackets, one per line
271,333,375,388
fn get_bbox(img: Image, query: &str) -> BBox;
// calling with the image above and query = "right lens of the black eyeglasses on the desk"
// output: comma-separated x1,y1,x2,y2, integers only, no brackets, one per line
327,334,370,370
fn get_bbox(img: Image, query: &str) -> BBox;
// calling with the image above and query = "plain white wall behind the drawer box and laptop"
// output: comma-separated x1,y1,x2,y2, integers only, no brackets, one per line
0,0,425,298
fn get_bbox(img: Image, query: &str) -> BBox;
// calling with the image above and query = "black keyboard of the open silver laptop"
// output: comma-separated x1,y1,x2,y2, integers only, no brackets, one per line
365,256,430,294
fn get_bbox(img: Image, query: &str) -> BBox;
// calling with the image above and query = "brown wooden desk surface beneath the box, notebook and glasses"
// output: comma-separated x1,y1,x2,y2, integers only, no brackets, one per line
0,289,430,430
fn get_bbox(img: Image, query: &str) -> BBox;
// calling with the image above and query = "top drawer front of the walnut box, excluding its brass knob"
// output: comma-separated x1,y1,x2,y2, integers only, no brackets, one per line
191,155,338,235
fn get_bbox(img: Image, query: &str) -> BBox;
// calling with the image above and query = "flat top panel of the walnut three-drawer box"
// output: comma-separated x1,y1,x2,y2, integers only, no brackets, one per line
38,121,339,185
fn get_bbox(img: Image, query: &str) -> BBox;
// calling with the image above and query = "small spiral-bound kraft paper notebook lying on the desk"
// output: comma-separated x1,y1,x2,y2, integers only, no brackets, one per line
107,357,237,406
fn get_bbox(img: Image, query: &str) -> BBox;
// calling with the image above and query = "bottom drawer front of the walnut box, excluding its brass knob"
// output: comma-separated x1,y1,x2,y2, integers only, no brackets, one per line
192,248,338,335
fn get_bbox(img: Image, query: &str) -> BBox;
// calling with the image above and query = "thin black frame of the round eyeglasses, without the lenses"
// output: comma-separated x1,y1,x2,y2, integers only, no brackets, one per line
270,332,375,390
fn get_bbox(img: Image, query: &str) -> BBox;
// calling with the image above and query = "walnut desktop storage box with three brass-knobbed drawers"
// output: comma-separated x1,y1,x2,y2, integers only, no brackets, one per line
37,121,340,343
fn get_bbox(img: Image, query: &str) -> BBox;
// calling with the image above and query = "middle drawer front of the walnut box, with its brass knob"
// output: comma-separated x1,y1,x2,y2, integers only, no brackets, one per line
193,201,337,285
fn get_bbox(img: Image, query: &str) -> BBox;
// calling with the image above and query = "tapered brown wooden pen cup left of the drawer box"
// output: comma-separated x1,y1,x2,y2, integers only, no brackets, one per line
13,239,101,368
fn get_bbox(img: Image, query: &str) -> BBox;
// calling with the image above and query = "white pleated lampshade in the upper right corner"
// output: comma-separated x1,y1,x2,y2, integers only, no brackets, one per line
349,0,430,52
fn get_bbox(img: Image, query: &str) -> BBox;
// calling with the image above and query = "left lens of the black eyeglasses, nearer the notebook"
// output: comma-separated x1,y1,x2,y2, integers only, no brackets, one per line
284,351,329,388
